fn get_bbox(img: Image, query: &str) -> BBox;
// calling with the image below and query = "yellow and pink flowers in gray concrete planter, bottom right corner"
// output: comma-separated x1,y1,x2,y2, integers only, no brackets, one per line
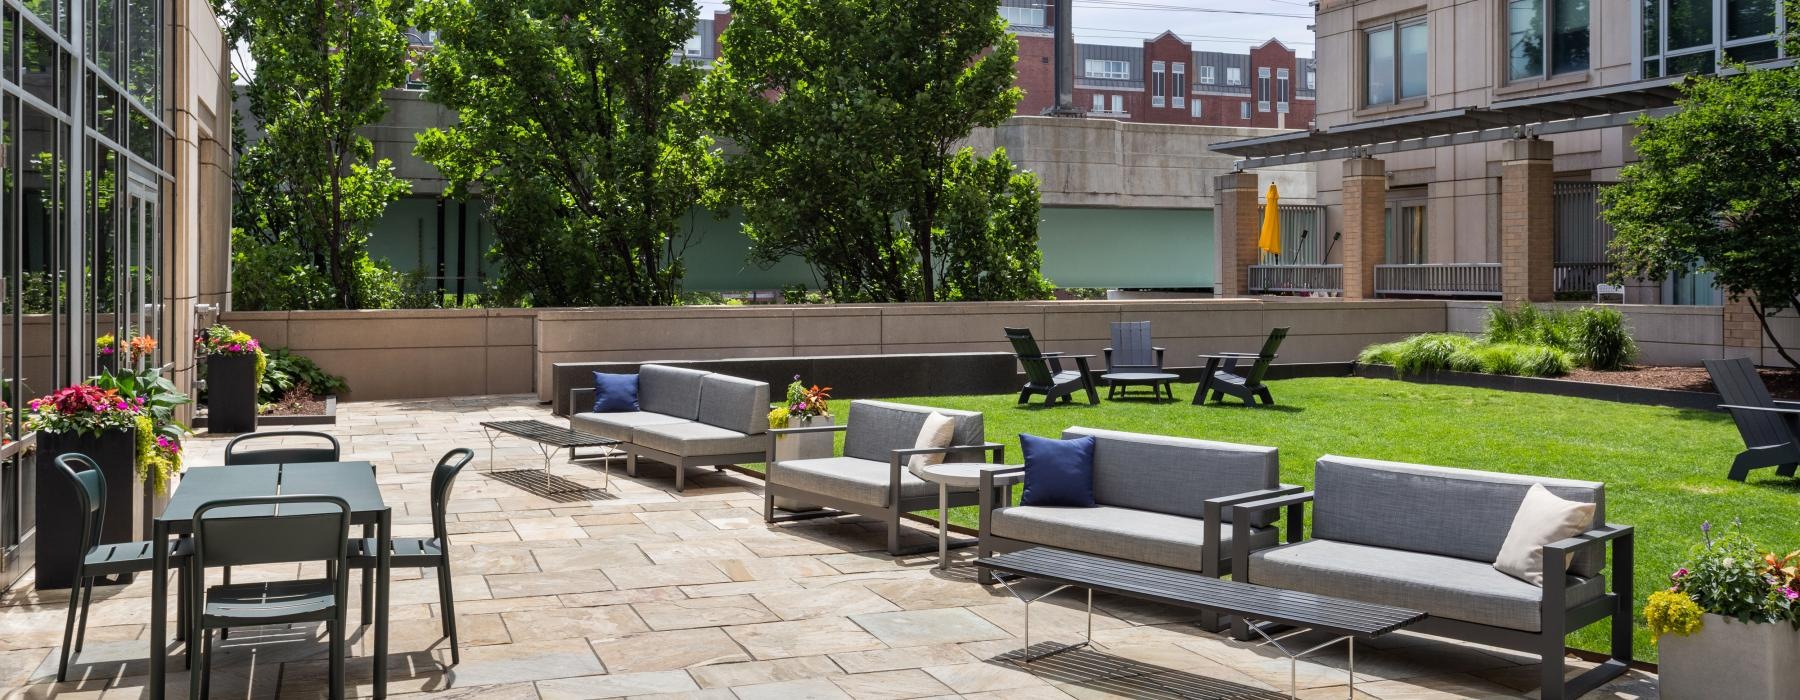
1643,514,1800,700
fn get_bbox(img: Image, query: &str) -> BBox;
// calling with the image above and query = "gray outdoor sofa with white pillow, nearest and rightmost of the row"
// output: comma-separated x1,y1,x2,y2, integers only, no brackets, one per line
1233,455,1633,700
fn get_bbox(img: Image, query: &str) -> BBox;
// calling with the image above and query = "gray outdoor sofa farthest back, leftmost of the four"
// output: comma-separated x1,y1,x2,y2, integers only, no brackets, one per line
569,365,769,491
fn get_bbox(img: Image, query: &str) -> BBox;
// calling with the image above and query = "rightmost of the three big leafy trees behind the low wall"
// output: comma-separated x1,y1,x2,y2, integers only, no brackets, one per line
704,0,1037,301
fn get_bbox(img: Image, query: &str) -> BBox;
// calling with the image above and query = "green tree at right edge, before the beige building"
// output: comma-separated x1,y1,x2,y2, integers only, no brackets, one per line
1604,60,1800,365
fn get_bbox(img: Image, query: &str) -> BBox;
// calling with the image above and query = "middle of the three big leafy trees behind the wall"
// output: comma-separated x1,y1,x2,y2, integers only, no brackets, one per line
418,0,718,306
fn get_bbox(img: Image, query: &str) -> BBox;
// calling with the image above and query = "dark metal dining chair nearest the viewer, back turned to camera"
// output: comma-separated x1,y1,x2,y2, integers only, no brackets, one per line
187,495,349,700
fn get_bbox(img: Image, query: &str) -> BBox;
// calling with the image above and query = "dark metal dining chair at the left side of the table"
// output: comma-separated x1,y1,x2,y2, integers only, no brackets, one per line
56,453,193,682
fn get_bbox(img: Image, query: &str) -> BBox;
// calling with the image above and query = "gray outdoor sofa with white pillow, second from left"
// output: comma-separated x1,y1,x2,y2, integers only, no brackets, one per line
763,399,1006,556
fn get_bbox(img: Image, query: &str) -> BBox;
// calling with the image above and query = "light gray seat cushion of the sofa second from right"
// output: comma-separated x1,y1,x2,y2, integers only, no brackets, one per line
992,506,1278,570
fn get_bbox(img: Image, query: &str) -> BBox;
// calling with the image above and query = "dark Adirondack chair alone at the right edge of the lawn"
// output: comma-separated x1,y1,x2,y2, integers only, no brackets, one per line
1705,358,1800,480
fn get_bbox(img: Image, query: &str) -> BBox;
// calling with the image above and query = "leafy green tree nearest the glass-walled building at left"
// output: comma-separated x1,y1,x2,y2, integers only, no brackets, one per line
221,0,410,308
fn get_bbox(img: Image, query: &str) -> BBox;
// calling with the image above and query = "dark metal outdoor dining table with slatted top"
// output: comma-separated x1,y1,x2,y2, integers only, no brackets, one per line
149,462,394,700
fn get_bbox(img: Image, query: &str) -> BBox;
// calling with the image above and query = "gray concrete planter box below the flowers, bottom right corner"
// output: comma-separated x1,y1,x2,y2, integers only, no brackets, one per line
1656,614,1800,700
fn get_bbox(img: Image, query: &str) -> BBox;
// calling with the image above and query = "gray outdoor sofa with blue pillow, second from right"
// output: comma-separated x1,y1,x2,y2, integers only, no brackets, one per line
979,428,1300,628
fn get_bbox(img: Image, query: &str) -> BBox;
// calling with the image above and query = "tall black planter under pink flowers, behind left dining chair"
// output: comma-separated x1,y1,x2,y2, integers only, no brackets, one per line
36,430,144,588
